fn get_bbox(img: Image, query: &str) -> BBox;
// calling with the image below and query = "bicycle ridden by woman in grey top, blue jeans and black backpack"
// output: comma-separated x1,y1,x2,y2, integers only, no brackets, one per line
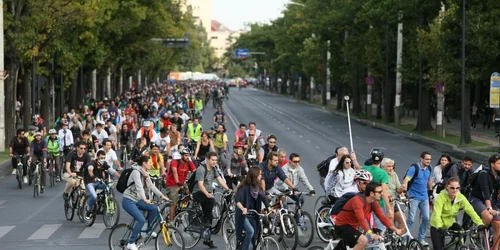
108,201,185,250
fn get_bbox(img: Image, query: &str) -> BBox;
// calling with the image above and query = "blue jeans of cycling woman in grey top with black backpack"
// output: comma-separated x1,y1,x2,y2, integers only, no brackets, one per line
122,197,158,244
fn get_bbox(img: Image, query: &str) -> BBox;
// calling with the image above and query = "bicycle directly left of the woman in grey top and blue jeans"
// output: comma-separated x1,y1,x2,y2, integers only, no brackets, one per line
80,179,120,229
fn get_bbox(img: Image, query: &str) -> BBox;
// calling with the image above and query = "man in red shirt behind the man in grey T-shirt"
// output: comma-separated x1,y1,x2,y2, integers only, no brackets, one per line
166,148,196,222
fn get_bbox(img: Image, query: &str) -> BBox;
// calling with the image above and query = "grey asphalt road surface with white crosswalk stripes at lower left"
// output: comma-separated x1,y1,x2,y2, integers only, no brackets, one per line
0,88,448,250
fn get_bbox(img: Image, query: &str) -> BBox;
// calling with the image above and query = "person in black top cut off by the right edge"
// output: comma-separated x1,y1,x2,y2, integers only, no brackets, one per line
469,154,500,249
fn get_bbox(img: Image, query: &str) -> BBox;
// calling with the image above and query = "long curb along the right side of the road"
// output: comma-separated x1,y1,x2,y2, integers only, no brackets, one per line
259,89,490,165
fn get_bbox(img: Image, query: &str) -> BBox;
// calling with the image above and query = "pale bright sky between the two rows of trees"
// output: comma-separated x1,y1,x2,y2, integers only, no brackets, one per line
212,0,290,31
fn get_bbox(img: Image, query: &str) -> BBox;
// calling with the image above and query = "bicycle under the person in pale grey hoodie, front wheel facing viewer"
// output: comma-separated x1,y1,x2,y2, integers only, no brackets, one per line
287,192,314,247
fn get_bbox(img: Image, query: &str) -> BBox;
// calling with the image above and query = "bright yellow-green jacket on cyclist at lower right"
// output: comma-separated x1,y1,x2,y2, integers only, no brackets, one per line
431,190,483,229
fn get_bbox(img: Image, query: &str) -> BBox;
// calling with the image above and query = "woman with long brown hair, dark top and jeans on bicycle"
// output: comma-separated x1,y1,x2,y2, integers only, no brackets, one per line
234,167,269,250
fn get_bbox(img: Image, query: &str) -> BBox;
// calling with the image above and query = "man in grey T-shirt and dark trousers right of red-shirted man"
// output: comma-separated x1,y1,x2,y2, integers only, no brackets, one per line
193,152,229,248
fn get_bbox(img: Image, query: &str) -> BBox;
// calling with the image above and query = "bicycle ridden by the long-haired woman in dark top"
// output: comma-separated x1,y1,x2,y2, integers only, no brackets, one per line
224,209,280,250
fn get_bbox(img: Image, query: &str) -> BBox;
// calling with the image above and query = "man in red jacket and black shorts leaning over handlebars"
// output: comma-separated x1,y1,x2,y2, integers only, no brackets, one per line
335,182,404,250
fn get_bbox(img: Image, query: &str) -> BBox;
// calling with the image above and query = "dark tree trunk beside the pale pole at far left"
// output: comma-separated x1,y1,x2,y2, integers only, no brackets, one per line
4,59,20,148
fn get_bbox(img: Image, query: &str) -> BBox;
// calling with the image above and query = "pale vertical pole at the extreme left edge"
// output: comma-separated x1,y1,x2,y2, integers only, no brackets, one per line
0,0,5,149
